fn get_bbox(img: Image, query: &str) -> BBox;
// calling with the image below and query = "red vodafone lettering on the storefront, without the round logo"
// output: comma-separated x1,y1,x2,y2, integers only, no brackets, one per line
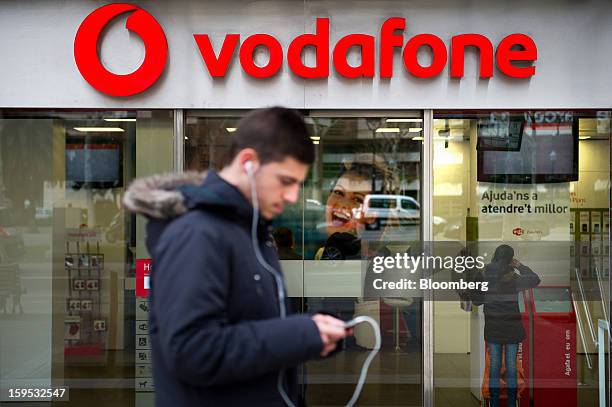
194,17,538,79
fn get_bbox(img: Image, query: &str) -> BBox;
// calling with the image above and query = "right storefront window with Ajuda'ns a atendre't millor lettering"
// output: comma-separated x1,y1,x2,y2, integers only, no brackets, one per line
433,111,610,406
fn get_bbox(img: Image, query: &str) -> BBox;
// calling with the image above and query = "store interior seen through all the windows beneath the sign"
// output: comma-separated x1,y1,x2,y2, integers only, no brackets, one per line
0,110,610,407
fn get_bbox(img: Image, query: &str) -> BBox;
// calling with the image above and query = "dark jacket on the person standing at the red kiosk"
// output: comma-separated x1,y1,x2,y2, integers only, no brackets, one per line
473,263,540,343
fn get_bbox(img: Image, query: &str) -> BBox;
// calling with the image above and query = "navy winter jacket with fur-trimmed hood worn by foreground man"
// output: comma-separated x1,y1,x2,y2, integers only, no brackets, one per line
124,172,322,407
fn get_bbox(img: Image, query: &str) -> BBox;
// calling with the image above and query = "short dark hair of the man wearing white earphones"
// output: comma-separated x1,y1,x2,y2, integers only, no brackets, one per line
228,107,315,165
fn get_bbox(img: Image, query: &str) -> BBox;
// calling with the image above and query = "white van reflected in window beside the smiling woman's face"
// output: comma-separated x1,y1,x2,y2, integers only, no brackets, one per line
363,194,446,232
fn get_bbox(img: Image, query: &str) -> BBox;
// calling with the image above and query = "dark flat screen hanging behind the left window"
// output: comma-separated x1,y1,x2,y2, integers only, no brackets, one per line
66,141,123,189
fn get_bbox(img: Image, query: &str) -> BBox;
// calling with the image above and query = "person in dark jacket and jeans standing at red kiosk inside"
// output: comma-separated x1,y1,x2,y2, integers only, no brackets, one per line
473,244,540,407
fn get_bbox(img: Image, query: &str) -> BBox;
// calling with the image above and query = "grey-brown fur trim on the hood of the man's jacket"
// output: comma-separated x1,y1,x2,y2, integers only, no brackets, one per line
123,171,206,219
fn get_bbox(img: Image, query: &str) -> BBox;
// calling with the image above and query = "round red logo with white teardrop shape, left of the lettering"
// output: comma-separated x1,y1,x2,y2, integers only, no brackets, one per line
74,3,168,96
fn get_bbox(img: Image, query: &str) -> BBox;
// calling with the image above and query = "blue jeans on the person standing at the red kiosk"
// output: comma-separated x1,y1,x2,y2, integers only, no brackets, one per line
488,342,518,407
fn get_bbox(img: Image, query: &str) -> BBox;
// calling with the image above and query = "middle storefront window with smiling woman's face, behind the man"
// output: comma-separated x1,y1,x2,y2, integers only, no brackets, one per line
185,112,423,405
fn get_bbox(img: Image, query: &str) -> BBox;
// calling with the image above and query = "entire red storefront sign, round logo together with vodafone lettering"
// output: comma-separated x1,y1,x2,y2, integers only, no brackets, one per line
74,4,538,96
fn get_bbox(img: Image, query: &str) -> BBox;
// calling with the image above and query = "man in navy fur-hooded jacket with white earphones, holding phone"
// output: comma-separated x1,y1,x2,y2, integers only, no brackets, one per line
124,107,352,407
